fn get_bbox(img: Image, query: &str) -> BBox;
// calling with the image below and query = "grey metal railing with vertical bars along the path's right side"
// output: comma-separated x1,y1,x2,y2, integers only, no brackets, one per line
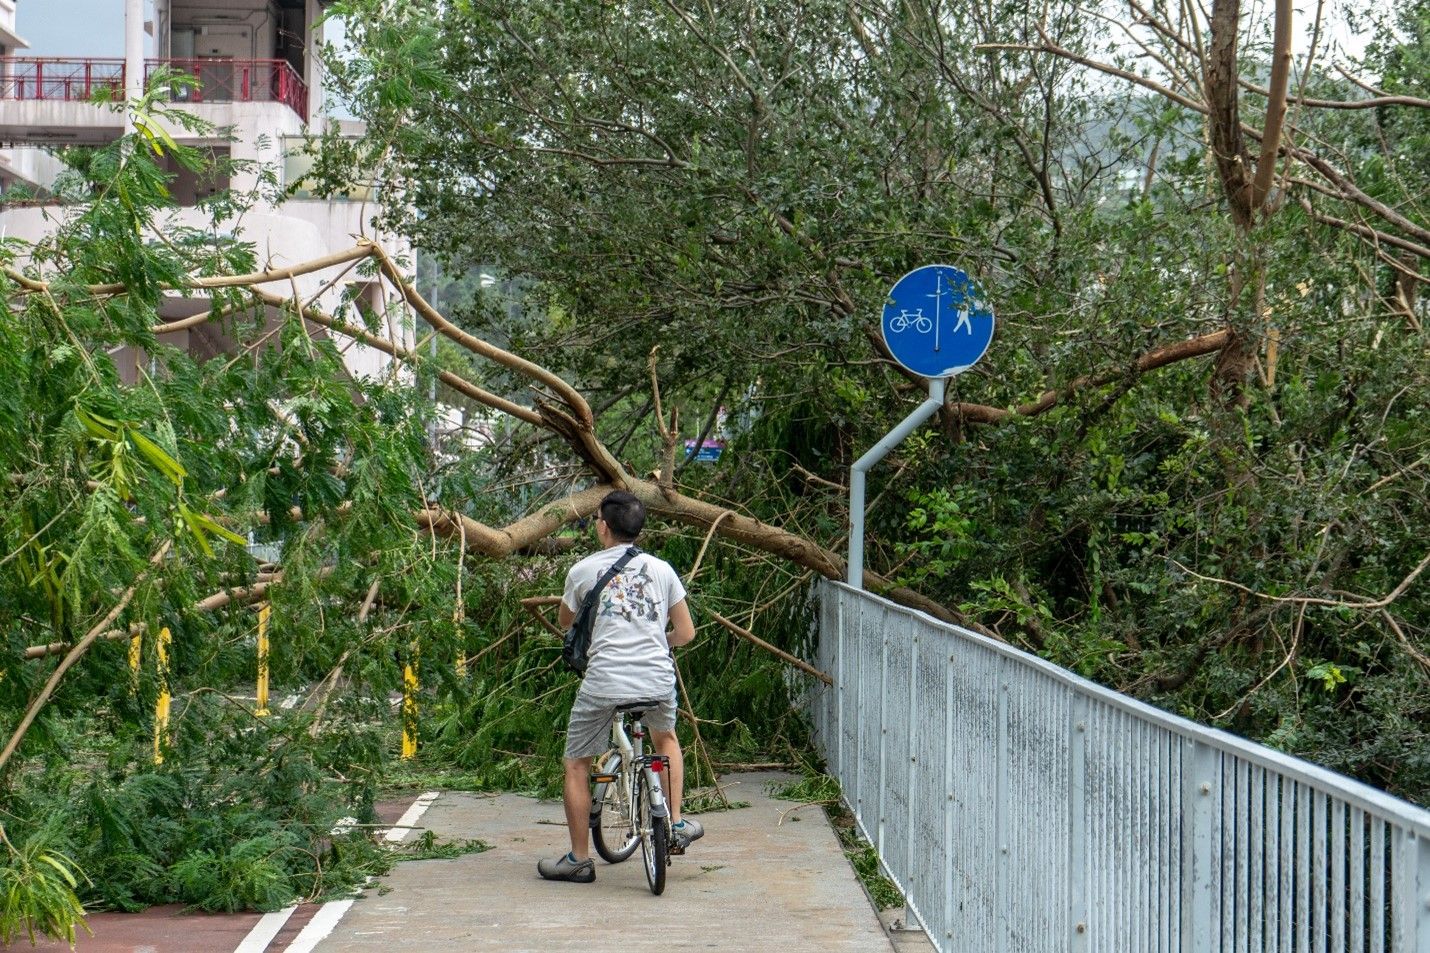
808,581,1430,953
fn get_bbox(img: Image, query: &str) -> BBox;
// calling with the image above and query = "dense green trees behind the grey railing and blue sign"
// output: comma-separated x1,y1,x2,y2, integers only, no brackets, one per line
327,0,1430,798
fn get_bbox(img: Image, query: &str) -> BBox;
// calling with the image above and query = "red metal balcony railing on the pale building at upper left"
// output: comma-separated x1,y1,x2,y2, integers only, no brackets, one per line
0,56,307,122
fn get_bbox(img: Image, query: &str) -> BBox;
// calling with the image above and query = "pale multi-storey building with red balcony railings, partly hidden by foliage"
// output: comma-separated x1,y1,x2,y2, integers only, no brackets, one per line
0,0,413,379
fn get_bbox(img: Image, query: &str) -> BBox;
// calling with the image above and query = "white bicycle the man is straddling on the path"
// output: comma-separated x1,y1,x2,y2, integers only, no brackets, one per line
591,701,685,896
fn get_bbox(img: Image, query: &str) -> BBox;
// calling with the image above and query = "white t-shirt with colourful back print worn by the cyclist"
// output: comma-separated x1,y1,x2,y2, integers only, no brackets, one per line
561,542,685,701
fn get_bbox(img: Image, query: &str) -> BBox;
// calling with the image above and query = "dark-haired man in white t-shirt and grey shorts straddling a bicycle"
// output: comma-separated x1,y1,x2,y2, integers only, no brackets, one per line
536,491,705,883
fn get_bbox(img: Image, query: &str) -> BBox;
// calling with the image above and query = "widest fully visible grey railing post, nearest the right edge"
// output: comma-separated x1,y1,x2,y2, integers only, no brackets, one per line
1181,738,1221,953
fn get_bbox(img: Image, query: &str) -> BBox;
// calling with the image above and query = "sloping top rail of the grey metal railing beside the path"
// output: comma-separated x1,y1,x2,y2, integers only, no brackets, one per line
824,580,1430,839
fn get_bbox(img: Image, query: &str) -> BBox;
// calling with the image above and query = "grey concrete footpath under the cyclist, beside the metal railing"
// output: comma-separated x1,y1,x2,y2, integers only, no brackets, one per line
316,773,922,953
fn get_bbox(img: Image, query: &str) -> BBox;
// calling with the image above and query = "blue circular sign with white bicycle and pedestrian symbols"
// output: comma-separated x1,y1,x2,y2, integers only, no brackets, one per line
882,265,994,378
